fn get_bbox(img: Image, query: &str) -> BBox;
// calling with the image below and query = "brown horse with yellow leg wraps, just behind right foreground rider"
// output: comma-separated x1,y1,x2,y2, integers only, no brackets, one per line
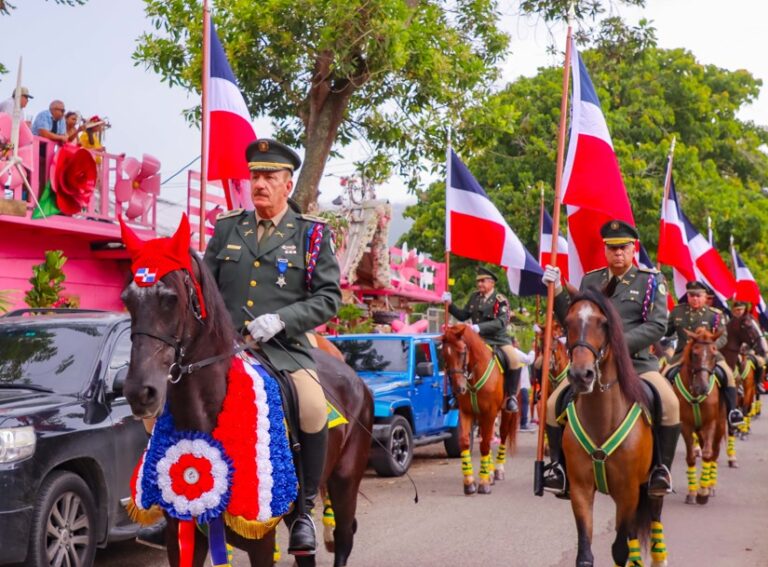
674,327,725,504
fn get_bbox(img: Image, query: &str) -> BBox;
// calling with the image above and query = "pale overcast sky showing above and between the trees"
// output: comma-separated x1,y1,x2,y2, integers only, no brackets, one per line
0,0,768,222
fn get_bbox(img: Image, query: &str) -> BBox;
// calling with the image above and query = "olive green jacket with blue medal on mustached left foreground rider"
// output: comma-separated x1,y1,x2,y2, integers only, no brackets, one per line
204,209,341,372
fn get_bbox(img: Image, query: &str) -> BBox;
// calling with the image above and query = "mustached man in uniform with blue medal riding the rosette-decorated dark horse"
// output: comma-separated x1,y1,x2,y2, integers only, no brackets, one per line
204,139,341,555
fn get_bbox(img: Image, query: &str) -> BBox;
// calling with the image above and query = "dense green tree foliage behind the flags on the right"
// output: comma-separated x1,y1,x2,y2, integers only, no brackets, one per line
404,19,768,304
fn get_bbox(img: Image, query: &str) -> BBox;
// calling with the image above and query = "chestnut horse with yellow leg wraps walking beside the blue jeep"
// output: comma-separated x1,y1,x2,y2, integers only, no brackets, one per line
442,323,519,495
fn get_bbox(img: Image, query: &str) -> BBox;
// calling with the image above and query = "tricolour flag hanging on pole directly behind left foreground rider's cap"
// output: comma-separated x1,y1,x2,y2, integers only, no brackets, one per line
208,22,256,184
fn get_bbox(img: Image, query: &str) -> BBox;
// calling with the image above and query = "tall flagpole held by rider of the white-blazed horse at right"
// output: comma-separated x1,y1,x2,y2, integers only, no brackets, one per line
533,10,575,496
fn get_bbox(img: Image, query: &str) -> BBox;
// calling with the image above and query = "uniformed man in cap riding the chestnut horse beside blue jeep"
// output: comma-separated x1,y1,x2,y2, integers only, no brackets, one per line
443,267,521,412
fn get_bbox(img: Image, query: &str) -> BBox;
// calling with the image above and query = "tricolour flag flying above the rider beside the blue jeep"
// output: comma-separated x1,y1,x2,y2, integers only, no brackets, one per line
445,148,547,295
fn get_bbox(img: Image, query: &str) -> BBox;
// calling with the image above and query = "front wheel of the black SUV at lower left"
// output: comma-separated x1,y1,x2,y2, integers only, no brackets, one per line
25,471,96,567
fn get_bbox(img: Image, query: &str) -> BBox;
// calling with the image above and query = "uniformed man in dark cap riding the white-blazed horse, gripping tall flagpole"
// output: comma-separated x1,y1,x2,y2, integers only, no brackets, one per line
542,220,680,496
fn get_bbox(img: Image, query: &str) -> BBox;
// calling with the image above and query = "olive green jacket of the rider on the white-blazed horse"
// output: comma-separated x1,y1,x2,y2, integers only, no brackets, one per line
554,266,669,374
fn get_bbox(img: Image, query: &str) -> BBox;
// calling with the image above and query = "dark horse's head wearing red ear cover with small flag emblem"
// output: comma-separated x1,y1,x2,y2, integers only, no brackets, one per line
120,215,234,424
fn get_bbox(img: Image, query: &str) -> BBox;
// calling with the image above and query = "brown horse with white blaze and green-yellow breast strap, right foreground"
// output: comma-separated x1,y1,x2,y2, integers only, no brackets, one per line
563,290,666,567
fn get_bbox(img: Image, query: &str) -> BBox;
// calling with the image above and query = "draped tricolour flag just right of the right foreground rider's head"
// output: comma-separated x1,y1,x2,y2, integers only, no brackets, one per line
659,179,736,309
